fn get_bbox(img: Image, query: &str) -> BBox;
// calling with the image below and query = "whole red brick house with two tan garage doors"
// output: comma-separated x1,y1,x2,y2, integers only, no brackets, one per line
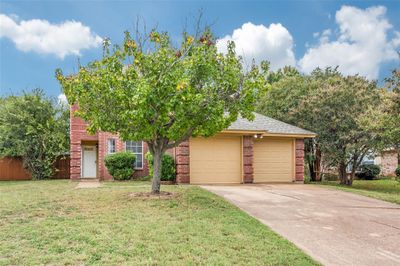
71,106,315,184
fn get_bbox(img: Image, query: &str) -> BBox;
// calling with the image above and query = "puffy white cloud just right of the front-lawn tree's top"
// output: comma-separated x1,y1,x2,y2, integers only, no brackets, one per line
217,22,296,70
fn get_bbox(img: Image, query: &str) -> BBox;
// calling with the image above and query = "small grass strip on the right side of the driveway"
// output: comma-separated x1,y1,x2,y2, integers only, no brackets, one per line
321,179,400,204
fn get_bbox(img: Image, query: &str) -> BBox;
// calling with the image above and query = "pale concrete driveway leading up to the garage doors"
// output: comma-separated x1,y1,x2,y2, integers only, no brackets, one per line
202,184,400,265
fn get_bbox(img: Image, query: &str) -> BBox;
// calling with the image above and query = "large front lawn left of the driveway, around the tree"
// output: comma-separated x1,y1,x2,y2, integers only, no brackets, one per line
0,180,316,265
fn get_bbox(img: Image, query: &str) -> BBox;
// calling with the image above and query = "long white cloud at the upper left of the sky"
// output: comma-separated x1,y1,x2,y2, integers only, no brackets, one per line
0,14,102,59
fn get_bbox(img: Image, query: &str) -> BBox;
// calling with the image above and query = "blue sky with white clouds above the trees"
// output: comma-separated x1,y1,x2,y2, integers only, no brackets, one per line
0,0,400,96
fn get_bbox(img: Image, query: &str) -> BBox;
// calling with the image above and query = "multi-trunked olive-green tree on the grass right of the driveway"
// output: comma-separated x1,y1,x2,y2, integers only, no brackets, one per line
304,70,380,185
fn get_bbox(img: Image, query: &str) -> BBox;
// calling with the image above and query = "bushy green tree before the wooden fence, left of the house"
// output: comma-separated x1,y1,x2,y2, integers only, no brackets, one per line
0,89,69,179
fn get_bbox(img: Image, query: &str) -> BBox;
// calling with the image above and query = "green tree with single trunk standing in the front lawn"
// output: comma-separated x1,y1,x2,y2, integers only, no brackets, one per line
56,30,268,193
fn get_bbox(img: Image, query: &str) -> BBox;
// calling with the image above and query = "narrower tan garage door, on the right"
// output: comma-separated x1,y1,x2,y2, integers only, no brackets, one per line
253,138,294,183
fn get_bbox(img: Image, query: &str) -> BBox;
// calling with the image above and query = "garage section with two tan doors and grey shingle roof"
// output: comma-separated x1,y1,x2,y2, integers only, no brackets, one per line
175,113,316,184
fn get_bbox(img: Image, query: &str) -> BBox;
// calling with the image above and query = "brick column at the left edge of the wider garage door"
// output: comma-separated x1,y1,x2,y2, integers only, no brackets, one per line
175,141,190,184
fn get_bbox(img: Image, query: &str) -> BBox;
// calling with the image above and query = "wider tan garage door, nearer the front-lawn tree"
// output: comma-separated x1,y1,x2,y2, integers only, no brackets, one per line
190,136,242,184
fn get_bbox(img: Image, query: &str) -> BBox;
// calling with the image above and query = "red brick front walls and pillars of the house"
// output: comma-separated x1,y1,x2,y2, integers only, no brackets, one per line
70,105,310,183
